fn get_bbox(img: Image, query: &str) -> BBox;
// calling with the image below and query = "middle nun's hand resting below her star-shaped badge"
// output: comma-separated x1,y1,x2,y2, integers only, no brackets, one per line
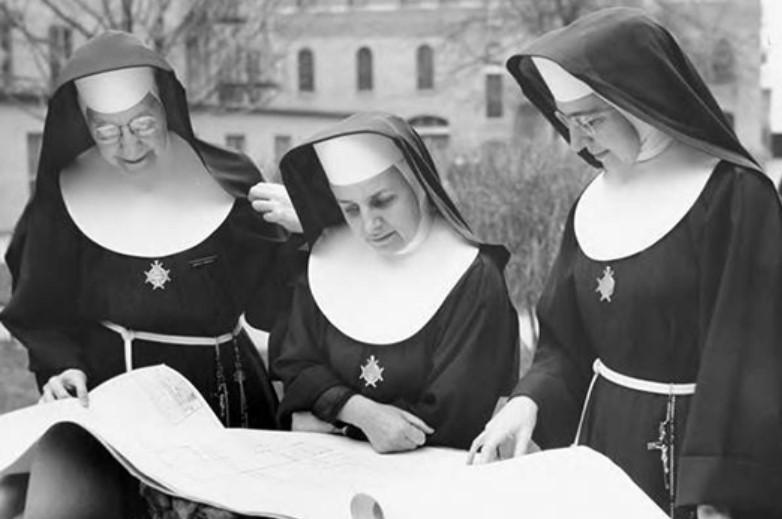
339,395,434,454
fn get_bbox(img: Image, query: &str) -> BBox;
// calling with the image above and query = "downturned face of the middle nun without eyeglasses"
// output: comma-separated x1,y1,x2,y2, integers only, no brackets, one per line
331,166,421,254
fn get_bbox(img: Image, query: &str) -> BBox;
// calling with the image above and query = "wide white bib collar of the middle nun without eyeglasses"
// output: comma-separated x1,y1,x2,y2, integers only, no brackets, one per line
308,217,478,344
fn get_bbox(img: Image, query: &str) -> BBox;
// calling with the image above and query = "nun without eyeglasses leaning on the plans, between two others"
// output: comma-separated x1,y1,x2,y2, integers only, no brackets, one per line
272,113,518,453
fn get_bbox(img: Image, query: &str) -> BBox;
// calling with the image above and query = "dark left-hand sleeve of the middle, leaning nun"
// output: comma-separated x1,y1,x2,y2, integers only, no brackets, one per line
270,273,353,423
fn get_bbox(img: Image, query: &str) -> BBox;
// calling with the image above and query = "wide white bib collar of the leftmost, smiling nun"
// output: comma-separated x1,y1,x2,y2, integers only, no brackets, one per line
60,132,234,258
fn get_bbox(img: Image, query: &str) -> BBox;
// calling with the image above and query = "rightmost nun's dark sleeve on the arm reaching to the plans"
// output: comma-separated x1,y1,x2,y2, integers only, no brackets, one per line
513,209,596,448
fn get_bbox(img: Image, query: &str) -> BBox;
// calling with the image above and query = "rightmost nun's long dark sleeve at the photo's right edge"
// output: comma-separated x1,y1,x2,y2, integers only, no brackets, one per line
677,168,782,509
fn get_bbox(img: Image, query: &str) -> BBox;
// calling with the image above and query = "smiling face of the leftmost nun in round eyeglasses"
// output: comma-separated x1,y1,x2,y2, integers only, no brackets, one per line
84,94,168,172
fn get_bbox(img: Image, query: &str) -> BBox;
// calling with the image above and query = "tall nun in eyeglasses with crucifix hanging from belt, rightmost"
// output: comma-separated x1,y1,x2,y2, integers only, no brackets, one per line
472,8,782,518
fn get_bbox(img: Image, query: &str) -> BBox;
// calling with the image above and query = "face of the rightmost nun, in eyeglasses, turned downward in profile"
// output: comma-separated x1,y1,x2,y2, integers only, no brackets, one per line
557,94,641,171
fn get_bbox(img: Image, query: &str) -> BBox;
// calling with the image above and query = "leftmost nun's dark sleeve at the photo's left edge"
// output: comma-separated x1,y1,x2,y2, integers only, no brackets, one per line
0,200,89,387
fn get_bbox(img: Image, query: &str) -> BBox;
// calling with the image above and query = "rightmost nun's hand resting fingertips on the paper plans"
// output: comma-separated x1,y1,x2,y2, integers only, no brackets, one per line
467,396,538,465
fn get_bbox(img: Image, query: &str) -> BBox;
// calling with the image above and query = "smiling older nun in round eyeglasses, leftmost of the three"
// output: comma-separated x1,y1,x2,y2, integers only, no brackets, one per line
0,31,304,517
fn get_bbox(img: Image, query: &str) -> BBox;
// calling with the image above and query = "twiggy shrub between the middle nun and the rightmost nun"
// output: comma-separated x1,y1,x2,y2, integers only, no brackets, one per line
445,140,594,312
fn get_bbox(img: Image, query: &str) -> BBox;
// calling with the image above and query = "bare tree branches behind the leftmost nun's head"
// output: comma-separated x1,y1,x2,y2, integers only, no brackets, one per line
0,0,285,107
